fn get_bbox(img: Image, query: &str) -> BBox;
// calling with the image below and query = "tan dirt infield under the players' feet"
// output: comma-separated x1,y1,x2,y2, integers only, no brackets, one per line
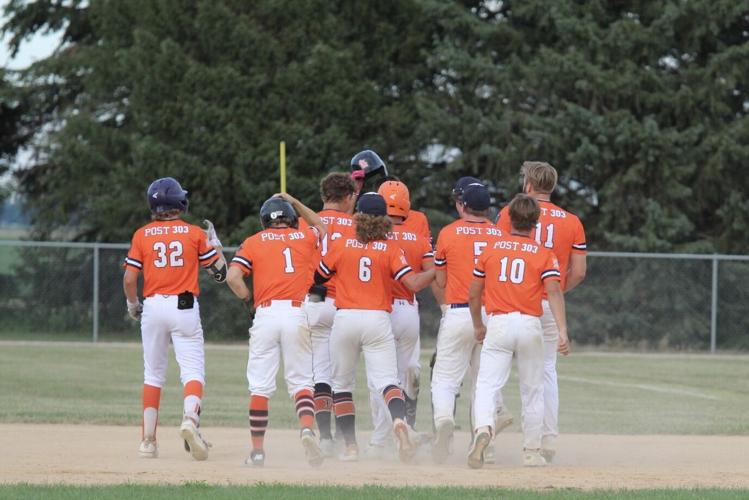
0,424,749,489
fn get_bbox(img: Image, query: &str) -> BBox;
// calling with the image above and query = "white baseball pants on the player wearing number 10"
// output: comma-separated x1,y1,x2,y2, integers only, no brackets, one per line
473,312,544,449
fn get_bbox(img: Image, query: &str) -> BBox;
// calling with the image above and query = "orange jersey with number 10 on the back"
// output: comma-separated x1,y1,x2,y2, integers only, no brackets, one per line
473,235,562,316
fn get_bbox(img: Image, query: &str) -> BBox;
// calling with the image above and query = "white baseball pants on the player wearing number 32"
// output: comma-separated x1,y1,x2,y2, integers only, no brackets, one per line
140,295,205,387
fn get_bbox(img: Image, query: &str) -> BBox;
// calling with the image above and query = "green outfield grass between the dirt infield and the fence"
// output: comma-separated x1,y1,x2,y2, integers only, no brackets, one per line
0,342,749,434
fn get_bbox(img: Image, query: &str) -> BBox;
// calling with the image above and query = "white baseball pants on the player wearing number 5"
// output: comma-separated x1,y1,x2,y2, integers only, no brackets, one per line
432,307,504,426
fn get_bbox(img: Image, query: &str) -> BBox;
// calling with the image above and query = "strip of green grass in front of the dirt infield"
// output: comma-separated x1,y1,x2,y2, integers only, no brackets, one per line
0,484,747,500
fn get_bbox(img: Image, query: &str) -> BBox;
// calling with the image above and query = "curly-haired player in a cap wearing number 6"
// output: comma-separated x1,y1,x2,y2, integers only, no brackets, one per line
315,193,434,461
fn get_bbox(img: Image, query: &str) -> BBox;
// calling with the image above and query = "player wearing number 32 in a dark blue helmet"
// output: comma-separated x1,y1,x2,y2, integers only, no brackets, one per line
123,177,226,460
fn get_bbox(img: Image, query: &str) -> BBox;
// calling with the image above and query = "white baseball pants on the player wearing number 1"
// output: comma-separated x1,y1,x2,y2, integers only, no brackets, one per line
247,300,314,398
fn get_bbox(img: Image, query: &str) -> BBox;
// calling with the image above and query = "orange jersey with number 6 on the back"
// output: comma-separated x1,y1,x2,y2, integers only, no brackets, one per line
318,237,413,312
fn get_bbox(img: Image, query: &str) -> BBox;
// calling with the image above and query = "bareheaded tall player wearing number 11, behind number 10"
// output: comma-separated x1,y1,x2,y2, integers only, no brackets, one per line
497,162,587,462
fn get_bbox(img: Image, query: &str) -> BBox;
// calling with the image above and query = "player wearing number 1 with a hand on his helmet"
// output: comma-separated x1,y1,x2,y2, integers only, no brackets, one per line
227,193,325,466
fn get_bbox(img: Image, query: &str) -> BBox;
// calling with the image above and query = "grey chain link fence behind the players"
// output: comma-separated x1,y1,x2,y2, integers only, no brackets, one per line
0,240,749,352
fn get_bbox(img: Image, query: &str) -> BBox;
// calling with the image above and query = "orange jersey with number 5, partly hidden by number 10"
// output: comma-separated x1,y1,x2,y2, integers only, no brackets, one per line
434,219,502,304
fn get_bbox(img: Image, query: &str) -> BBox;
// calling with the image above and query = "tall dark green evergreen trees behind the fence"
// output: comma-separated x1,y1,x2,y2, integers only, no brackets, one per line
0,0,749,253
